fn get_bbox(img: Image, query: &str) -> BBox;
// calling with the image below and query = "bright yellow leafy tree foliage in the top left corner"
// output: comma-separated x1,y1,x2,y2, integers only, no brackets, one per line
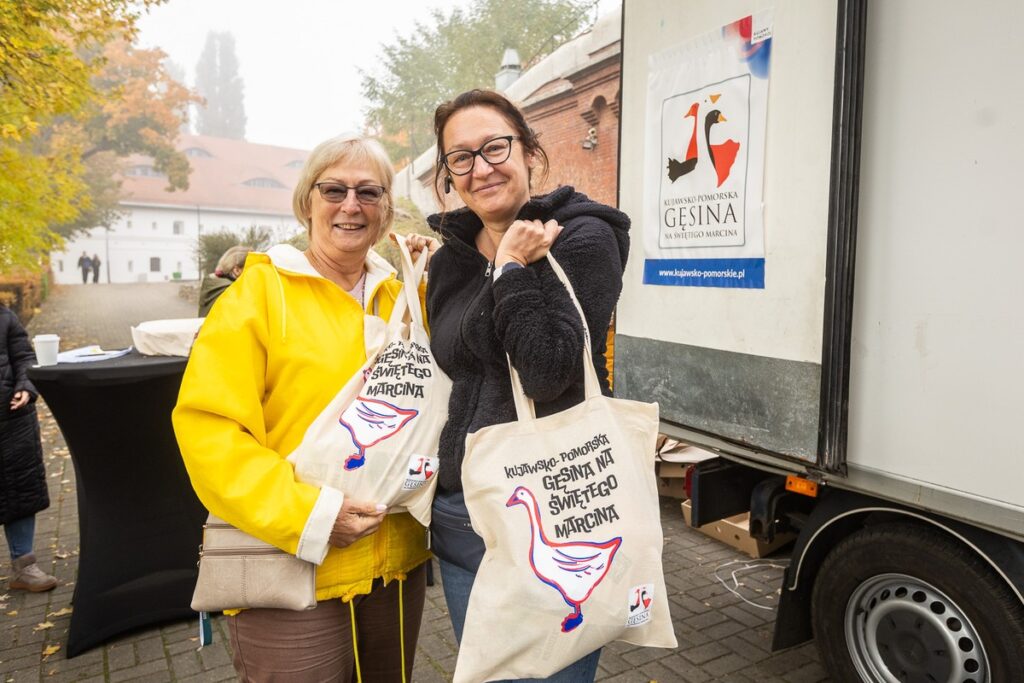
0,0,153,269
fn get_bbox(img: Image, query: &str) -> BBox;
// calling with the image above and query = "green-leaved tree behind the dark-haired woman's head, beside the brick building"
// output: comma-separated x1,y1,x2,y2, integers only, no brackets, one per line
362,0,596,162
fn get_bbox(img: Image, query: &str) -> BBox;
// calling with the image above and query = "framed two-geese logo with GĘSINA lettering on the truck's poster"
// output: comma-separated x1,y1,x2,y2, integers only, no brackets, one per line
658,84,751,248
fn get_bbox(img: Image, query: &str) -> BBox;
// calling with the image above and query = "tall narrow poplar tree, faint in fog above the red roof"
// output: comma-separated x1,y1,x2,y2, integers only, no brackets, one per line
196,31,246,140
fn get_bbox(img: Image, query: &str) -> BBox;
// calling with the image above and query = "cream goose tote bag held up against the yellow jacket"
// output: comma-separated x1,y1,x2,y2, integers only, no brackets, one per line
288,240,452,526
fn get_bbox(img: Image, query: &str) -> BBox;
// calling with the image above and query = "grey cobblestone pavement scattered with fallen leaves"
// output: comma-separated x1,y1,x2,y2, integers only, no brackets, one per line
0,284,827,683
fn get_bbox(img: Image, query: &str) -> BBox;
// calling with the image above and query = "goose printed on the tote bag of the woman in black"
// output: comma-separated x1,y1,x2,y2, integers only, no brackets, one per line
505,486,623,633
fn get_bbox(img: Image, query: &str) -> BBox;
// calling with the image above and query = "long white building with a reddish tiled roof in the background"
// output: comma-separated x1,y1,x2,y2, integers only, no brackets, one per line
50,135,309,285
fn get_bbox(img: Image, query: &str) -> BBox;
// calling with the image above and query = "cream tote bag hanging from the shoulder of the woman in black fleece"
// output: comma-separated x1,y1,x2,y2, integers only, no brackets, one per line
455,254,676,683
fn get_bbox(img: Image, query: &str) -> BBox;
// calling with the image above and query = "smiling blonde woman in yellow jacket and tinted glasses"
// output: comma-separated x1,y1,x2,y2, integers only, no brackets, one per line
174,135,430,681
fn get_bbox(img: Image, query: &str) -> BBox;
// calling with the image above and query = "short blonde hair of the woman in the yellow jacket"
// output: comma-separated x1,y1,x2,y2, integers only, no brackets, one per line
292,133,394,243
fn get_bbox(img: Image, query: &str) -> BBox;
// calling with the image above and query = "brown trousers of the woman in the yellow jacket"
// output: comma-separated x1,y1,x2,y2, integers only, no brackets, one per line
227,564,427,683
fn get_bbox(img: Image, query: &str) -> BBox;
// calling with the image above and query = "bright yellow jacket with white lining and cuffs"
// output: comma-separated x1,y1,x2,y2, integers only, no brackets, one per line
173,245,430,600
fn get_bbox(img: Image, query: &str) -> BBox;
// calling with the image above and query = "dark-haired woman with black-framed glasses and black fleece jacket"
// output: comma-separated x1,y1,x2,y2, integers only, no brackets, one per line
409,90,630,682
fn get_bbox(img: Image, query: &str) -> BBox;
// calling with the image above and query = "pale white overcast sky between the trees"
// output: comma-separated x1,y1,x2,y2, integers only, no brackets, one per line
138,0,617,150
